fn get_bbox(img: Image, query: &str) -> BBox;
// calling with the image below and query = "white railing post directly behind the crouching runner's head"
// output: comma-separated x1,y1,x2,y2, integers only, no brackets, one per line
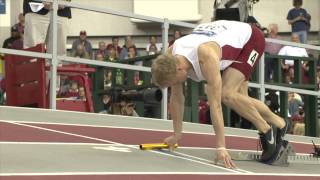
161,18,169,119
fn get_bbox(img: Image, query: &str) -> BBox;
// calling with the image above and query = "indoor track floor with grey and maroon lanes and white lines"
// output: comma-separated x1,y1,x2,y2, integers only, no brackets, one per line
0,106,320,180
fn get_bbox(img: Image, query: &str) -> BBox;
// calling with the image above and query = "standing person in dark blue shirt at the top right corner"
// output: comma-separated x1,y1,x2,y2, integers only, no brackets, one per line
287,0,311,43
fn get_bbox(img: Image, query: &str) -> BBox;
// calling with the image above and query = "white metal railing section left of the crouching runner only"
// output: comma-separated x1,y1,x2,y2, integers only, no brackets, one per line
0,0,196,119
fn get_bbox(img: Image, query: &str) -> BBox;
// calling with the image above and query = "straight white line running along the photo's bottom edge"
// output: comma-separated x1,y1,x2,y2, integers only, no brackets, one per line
0,171,320,177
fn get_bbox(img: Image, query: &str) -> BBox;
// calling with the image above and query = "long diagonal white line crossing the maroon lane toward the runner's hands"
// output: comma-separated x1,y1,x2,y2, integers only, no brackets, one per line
5,122,241,174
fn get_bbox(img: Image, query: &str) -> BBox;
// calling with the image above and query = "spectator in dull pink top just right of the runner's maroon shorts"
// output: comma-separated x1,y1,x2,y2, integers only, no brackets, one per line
265,24,282,81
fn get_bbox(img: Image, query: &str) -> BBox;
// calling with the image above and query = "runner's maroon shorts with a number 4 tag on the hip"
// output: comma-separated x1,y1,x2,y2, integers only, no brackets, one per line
229,26,265,80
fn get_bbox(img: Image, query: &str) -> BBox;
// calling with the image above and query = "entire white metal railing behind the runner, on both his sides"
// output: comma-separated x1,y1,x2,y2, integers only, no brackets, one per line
0,0,320,135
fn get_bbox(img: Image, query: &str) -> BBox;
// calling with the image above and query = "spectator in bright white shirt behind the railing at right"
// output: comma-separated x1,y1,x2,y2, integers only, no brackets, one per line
278,34,308,82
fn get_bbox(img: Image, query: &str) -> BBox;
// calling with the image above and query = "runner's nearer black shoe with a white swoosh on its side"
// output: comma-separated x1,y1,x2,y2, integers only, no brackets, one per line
260,125,277,162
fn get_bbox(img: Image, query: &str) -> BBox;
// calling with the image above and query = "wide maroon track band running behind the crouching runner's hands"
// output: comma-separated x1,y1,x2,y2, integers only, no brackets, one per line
0,122,314,153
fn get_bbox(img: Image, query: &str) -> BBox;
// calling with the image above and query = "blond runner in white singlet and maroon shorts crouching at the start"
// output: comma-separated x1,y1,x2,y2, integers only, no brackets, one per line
151,20,287,168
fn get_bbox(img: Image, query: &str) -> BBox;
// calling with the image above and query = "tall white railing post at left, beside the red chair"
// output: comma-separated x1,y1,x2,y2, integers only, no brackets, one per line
50,0,58,109
